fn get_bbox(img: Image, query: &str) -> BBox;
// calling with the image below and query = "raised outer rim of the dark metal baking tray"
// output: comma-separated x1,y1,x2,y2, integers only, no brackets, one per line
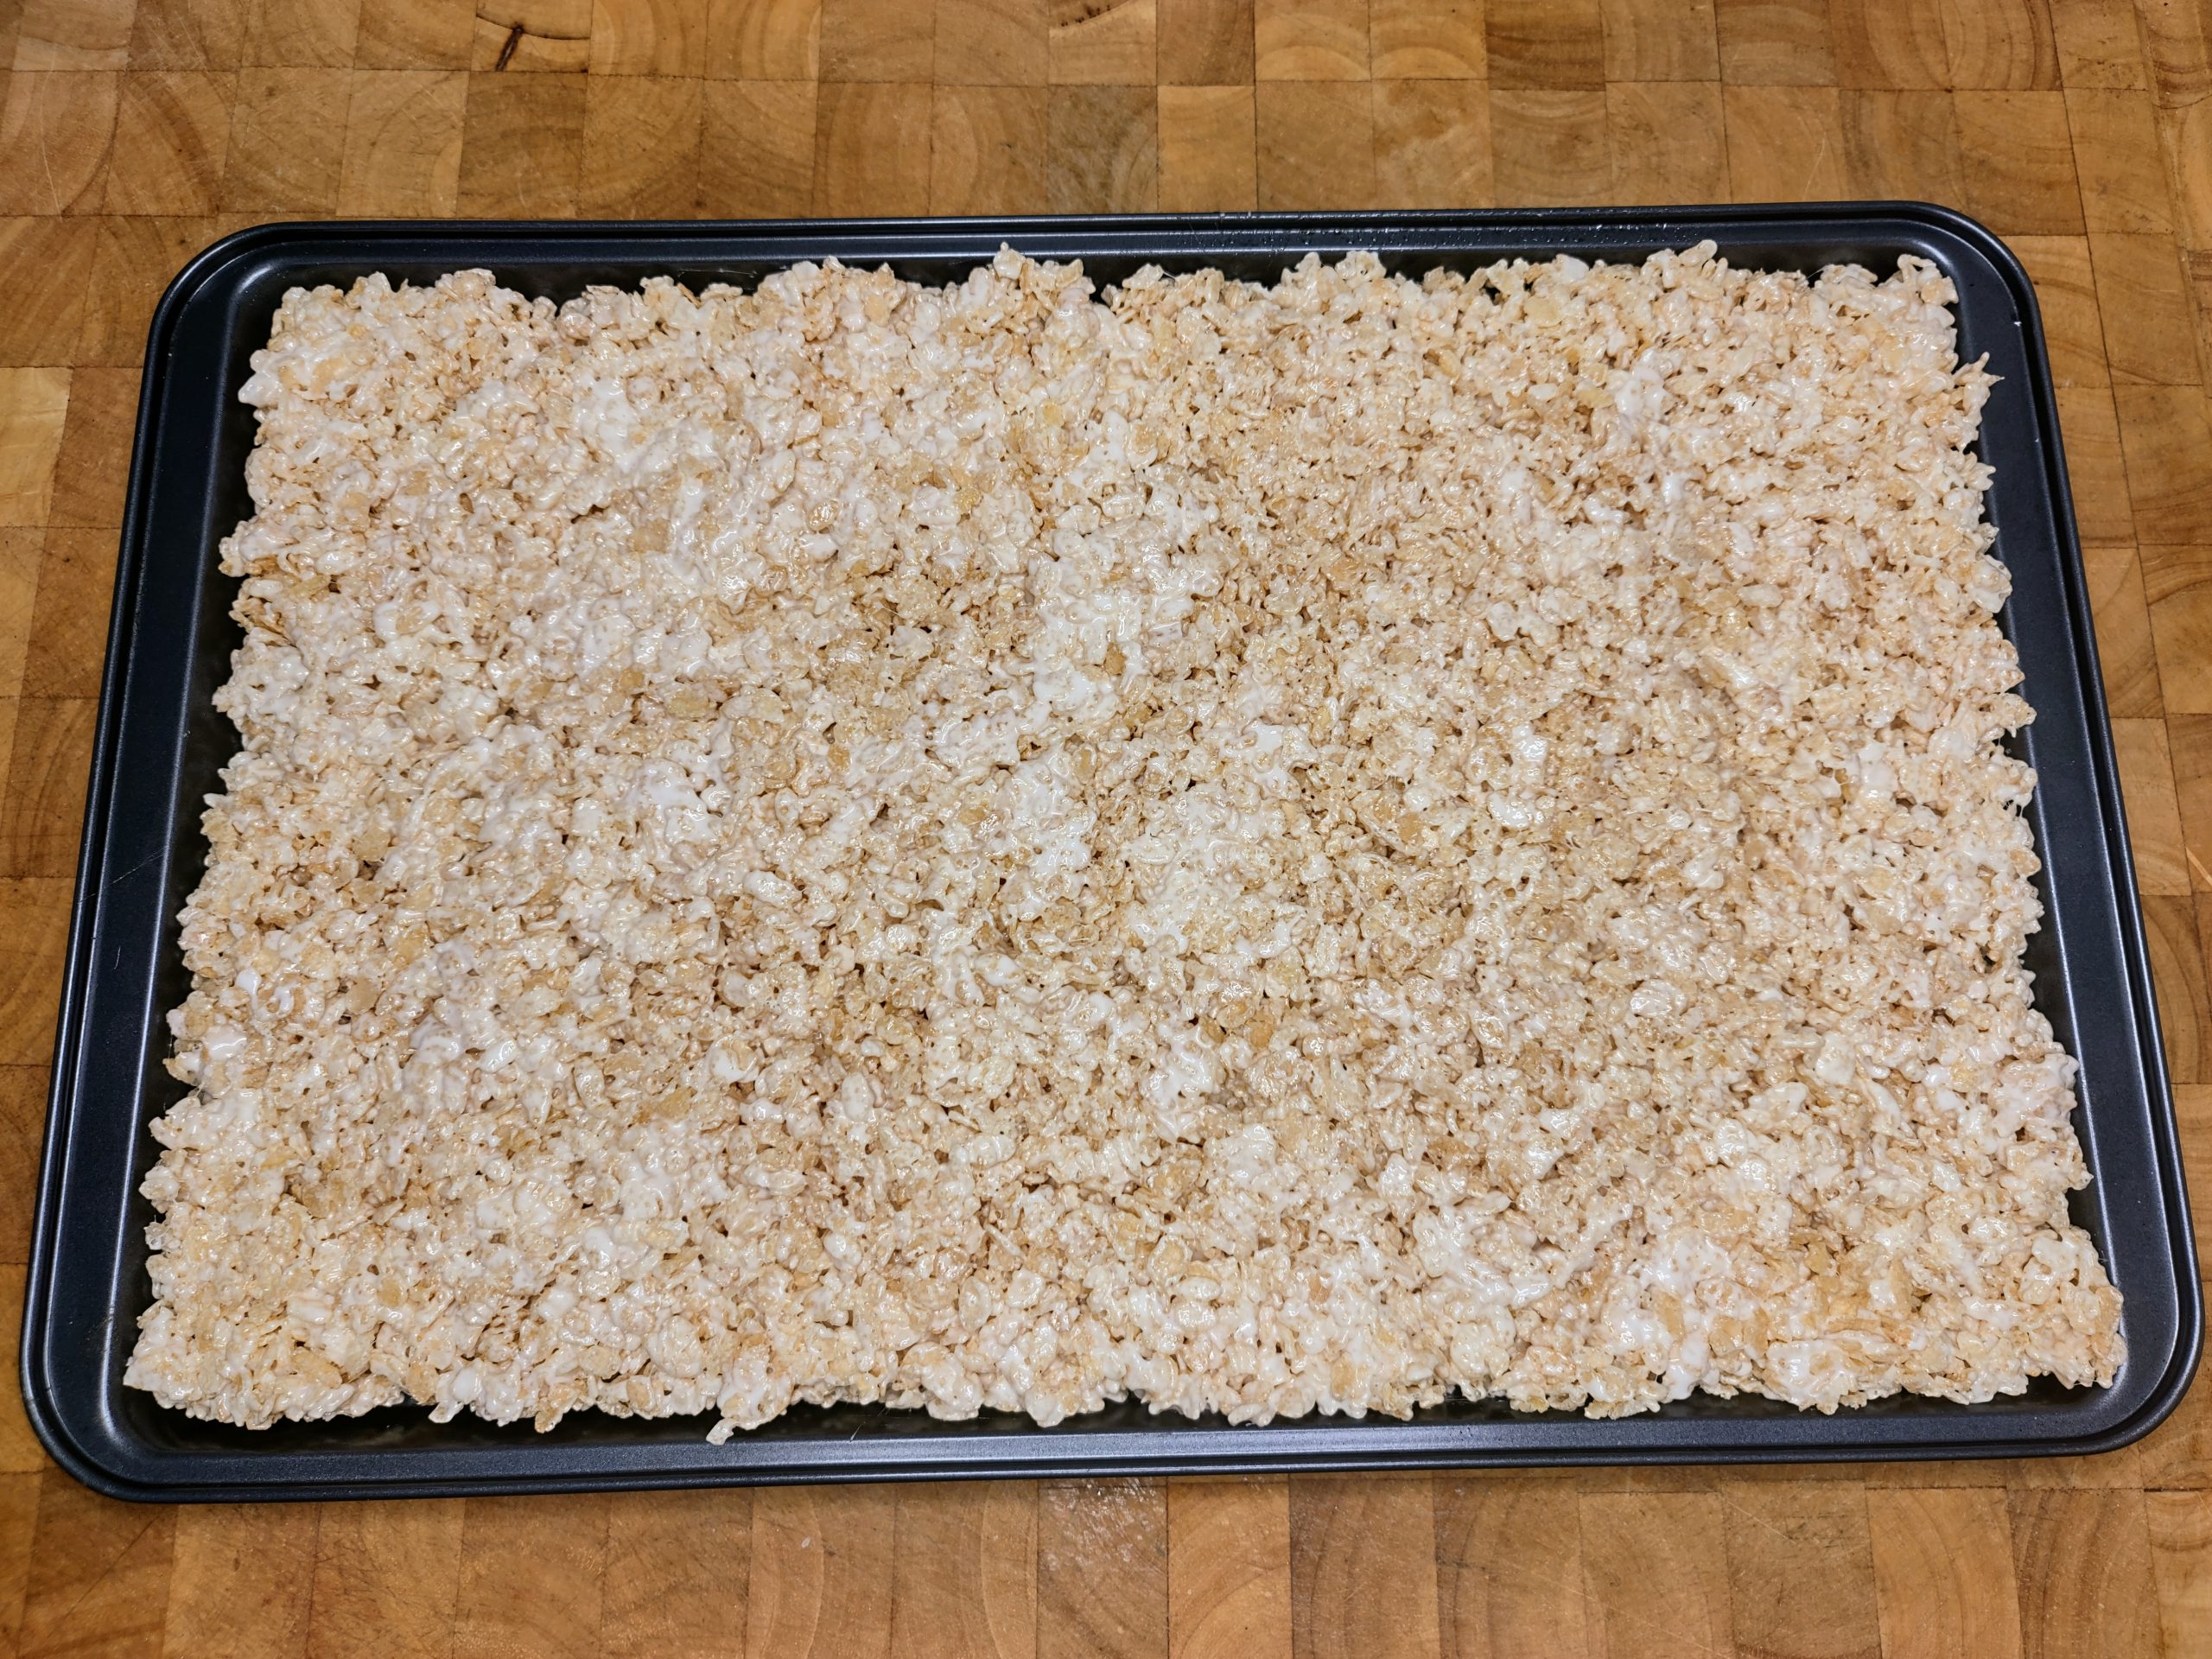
17,199,2203,1502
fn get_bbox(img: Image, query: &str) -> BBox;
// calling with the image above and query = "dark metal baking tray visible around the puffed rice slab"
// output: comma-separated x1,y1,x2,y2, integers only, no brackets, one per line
22,204,2203,1500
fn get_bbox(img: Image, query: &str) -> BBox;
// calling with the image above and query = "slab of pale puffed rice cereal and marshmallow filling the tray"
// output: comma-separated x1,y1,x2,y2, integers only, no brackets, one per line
128,248,2121,1433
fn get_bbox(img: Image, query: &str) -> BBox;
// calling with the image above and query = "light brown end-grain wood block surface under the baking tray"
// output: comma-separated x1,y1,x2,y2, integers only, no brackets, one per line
0,0,2212,1659
